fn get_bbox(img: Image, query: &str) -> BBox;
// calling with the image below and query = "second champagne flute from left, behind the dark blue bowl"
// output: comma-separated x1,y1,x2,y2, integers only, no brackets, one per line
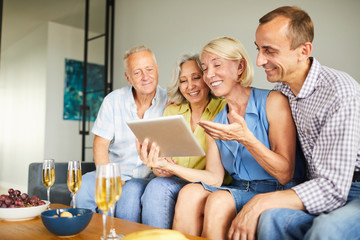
67,161,81,208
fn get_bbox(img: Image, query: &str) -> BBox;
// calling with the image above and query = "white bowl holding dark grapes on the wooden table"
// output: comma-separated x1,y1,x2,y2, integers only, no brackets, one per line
0,200,50,221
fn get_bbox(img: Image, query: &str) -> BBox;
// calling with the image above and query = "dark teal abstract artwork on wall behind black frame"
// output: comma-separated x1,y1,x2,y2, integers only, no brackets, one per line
63,59,104,121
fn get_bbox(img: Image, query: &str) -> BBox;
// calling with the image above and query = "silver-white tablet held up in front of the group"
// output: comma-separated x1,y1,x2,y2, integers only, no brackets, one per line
127,115,205,157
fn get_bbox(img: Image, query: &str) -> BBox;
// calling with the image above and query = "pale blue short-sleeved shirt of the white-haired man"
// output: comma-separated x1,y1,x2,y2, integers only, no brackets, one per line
92,86,168,181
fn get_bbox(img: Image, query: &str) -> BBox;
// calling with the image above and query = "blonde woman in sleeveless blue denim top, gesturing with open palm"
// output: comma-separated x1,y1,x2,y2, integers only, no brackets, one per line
173,37,304,239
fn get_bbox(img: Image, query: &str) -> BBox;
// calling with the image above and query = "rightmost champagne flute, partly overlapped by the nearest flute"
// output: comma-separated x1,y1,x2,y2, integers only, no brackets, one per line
108,162,124,239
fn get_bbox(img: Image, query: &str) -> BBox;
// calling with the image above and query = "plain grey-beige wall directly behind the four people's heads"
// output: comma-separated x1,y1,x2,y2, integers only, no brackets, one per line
115,0,360,88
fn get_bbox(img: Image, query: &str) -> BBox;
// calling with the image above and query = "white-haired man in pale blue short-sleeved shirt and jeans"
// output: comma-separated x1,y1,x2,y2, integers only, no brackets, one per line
76,46,168,222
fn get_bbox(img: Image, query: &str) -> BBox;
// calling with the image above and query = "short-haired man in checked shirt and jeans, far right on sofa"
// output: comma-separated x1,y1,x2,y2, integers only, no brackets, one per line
229,7,360,239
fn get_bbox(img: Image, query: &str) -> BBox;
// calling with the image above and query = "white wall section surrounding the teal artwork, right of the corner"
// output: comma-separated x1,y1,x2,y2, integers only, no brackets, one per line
44,23,104,162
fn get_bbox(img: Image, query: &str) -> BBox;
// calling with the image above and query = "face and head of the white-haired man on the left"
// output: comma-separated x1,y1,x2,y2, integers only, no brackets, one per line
125,51,159,96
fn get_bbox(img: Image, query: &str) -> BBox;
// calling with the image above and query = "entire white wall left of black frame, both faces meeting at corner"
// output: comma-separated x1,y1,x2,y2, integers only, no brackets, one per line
0,22,104,191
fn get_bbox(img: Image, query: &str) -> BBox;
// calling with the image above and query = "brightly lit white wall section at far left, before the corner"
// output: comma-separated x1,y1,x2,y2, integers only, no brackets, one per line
0,25,47,190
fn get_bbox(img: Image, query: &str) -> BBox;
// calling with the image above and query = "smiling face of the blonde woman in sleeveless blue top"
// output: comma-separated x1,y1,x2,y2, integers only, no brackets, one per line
201,51,244,97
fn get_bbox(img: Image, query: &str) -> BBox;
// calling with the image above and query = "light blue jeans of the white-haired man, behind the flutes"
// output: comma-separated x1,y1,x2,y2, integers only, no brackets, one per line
76,171,151,222
